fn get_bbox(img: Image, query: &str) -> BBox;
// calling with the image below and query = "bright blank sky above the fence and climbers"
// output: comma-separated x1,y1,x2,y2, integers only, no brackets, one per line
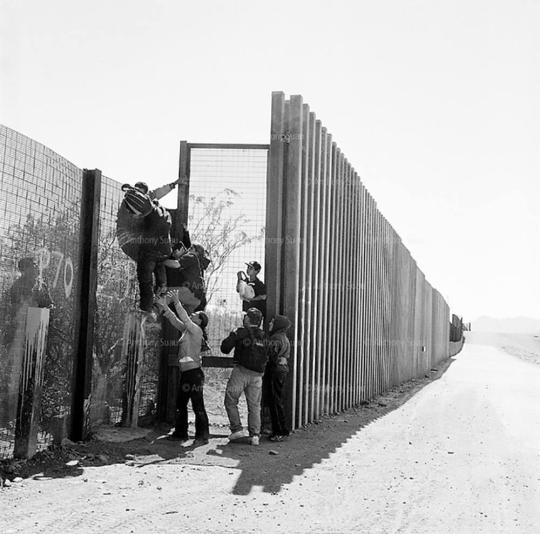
0,0,540,320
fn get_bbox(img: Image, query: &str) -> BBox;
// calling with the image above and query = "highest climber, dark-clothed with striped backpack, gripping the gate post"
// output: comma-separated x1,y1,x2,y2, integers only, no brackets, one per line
116,182,179,318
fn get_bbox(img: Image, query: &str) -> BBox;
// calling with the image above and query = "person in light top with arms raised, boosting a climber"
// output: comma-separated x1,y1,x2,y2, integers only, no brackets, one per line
157,291,210,445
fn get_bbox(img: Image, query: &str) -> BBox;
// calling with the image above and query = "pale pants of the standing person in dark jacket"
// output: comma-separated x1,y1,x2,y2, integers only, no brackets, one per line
225,365,262,436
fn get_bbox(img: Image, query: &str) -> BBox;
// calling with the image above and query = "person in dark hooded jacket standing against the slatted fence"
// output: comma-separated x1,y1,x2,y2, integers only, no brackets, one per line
263,315,291,441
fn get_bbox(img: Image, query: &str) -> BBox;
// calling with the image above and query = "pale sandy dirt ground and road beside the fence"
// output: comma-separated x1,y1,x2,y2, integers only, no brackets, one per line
0,333,540,534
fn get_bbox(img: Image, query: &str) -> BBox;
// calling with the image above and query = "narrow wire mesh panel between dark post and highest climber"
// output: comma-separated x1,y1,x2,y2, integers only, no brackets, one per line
89,176,161,432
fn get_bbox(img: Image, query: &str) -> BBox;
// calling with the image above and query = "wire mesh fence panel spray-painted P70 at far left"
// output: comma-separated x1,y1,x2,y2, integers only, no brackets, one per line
0,126,82,457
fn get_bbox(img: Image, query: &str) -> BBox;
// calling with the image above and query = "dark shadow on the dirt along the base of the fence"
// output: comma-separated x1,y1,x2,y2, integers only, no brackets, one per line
0,358,454,495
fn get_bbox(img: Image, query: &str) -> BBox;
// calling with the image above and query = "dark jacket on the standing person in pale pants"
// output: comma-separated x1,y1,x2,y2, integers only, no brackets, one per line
221,326,268,373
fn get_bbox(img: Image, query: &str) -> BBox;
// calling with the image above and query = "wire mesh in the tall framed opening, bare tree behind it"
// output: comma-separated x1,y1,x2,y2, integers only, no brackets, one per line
188,145,267,355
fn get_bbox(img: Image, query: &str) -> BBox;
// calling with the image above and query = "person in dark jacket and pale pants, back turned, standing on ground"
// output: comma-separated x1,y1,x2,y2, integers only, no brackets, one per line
221,308,268,445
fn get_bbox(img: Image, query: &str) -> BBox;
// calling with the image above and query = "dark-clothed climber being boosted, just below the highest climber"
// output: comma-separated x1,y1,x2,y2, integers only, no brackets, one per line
167,243,210,312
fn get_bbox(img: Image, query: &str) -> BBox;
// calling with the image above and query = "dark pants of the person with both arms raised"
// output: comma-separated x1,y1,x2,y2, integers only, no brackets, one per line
174,368,210,439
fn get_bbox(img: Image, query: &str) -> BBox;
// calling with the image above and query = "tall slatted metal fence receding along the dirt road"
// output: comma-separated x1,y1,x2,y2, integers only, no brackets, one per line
266,92,449,427
